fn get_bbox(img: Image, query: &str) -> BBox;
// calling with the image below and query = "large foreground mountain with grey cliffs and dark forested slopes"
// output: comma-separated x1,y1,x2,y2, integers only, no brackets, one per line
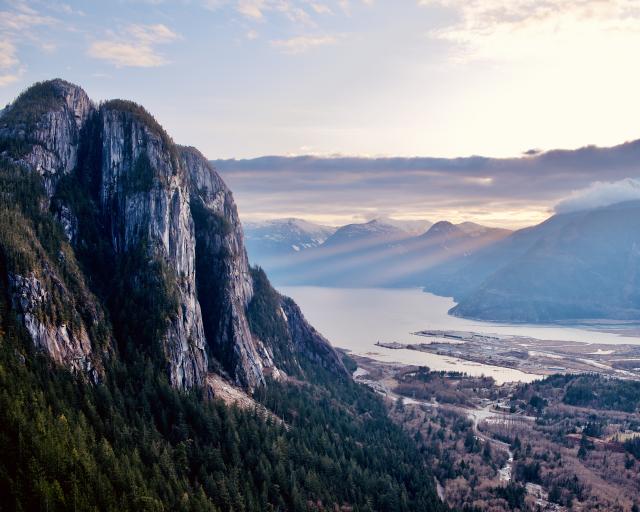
0,80,445,512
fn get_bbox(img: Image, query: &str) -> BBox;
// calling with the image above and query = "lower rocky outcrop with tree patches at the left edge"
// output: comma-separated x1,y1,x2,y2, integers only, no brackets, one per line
0,184,112,382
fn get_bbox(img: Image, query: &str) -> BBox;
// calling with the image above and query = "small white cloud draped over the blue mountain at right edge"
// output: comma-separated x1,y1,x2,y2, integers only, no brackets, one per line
555,178,640,213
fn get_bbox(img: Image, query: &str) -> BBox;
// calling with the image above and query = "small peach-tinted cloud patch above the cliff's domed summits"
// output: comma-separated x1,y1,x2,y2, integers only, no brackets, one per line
87,24,179,68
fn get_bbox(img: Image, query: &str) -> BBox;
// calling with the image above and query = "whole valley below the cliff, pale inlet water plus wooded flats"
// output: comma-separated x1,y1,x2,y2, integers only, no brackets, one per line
286,287,640,512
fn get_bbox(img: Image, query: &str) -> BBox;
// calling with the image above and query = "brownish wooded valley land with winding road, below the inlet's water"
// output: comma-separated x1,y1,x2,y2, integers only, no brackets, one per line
352,356,640,512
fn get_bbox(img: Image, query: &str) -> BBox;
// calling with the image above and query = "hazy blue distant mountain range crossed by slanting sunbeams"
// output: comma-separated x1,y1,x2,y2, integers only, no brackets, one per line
245,218,510,286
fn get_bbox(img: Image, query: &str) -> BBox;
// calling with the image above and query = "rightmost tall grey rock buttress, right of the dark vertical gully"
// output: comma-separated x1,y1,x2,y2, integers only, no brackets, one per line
180,148,275,389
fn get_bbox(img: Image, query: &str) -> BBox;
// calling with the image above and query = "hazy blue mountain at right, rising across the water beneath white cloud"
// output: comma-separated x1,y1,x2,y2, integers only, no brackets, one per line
427,201,640,322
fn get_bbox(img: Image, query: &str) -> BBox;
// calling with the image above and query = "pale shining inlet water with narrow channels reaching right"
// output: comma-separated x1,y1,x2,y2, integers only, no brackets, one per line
280,286,640,382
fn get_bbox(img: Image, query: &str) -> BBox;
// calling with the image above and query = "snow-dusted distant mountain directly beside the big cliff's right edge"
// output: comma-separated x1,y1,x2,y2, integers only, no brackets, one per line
243,218,336,268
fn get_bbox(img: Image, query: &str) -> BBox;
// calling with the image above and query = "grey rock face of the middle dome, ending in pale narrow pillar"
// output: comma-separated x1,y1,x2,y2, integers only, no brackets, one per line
99,102,207,387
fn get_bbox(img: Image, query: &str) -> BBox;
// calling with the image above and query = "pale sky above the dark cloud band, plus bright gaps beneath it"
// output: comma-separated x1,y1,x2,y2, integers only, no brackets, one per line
0,0,640,225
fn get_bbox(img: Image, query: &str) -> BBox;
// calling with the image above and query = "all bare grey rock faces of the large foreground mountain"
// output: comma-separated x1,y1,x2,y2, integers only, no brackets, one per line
0,80,341,391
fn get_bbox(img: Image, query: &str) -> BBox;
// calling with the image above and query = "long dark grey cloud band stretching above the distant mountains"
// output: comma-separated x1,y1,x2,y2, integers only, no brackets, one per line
214,141,640,228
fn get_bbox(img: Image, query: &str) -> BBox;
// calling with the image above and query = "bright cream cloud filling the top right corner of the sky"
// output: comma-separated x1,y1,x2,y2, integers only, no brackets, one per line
418,0,640,60
